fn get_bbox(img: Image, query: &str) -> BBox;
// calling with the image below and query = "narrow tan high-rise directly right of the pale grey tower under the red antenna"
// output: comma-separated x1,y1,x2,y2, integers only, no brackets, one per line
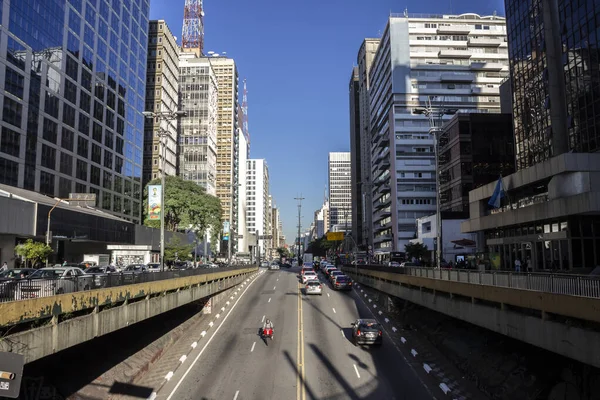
209,55,241,253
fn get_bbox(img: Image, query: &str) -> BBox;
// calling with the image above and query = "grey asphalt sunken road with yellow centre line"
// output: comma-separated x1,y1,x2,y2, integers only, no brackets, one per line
157,268,433,400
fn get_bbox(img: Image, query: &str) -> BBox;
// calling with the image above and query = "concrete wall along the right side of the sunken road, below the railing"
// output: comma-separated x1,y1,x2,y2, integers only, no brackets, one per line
346,270,600,368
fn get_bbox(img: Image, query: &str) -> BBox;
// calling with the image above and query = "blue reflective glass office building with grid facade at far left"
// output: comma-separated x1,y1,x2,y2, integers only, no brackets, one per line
0,0,149,222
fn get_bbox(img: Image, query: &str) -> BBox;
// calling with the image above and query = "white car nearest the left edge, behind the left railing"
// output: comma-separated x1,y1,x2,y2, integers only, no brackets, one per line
15,267,94,300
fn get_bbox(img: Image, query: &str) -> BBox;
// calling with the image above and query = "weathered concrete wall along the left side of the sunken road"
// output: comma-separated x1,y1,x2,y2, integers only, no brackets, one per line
0,272,255,363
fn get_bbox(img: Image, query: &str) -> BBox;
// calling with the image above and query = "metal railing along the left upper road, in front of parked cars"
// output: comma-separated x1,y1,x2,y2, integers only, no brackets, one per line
0,265,249,303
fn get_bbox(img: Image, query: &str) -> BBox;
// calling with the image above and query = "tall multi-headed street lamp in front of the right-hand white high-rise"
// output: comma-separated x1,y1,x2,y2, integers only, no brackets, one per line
413,96,458,268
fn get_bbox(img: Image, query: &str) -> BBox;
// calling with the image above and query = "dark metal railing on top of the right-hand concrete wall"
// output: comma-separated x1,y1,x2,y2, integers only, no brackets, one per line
346,265,600,298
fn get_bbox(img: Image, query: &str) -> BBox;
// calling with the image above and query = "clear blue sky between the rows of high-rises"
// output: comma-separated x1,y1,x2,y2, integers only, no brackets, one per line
150,0,504,243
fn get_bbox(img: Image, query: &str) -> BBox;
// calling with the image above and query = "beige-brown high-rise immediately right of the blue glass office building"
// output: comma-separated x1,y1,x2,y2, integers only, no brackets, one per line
142,20,179,187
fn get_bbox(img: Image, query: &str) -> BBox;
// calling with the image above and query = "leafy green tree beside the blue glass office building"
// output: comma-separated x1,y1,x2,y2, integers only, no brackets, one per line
144,176,222,250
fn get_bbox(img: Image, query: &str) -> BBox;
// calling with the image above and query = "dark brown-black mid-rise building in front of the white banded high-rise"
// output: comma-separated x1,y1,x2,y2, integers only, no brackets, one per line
439,113,515,212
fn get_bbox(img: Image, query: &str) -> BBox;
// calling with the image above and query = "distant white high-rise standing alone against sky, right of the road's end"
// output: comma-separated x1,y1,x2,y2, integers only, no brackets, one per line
328,152,352,232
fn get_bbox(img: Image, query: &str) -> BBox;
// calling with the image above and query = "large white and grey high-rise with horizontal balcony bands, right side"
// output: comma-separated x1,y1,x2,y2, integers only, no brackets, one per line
369,14,508,256
